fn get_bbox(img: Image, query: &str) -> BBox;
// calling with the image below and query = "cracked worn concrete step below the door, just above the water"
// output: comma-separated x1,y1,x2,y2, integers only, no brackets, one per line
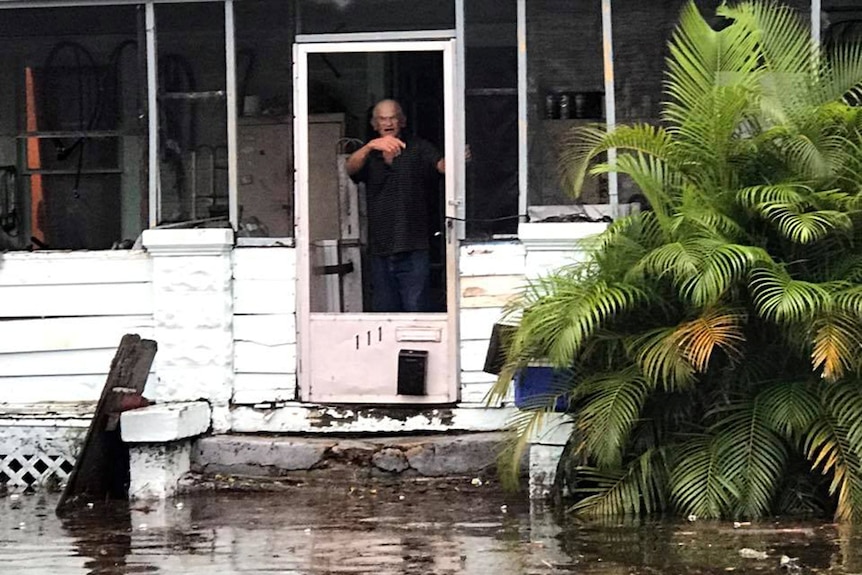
191,432,508,481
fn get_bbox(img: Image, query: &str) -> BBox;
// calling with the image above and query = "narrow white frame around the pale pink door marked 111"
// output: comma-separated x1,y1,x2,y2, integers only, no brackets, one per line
293,38,463,401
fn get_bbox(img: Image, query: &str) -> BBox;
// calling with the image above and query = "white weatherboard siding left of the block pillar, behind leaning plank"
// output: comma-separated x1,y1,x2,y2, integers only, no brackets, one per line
0,250,153,404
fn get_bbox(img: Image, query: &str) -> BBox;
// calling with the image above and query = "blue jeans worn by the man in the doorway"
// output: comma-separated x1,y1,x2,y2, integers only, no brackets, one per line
371,250,431,312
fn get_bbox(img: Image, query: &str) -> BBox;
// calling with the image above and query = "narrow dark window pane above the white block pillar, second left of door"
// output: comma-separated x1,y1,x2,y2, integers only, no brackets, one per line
156,2,228,224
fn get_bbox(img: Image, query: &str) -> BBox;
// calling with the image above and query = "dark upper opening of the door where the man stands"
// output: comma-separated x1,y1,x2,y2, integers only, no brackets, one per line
307,51,446,313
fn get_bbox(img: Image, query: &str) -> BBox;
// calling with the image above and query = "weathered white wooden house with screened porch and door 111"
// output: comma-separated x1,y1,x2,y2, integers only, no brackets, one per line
0,0,862,490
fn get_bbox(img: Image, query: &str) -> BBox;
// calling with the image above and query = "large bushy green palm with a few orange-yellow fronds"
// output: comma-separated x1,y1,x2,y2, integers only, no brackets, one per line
492,1,862,520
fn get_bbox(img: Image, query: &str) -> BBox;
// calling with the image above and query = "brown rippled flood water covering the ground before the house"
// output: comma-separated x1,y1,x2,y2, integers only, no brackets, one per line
0,481,862,575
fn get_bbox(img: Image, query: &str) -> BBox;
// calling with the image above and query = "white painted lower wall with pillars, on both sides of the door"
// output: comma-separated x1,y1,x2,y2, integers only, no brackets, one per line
0,225,600,438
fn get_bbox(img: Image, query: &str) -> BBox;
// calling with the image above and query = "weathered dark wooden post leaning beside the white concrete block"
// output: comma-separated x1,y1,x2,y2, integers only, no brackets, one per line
56,334,157,515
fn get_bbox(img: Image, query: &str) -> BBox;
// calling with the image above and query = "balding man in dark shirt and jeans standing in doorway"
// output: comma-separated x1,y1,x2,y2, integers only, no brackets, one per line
346,100,446,312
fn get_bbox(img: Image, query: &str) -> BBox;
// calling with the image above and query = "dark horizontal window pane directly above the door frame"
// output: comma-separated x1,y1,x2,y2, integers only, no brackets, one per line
296,0,455,34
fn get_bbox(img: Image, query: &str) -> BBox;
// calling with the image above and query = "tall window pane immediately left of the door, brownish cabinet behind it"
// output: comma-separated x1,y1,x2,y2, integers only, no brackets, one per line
234,0,294,237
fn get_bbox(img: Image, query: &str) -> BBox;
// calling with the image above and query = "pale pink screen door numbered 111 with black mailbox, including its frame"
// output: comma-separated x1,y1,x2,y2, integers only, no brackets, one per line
294,40,461,404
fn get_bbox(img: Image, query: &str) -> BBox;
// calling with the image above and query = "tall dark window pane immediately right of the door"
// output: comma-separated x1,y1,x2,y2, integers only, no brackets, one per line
464,0,518,239
